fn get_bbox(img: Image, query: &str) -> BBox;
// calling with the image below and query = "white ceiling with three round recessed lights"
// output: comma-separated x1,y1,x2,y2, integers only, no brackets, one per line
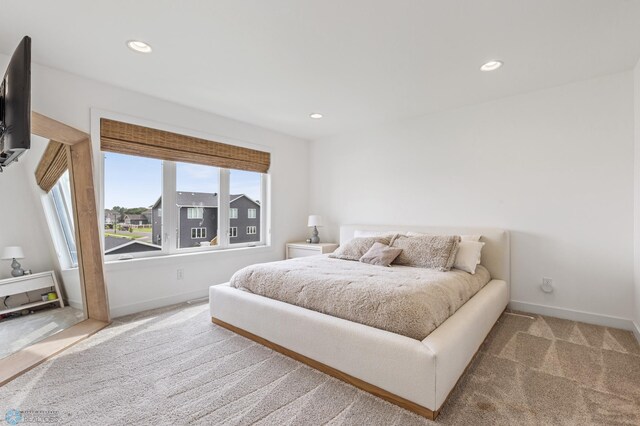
0,0,640,139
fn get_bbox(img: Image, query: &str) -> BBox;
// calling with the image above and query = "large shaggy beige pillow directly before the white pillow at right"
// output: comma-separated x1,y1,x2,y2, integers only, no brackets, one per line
392,235,460,271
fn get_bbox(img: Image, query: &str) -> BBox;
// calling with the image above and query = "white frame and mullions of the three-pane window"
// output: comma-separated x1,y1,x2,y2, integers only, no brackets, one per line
98,151,270,262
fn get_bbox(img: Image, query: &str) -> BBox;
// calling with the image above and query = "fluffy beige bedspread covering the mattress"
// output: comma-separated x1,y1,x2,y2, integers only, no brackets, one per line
231,256,490,340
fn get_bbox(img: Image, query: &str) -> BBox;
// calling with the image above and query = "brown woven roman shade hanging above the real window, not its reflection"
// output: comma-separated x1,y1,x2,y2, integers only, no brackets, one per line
100,118,271,173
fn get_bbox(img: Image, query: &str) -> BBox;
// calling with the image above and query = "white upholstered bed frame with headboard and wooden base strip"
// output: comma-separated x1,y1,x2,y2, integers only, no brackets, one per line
209,225,510,419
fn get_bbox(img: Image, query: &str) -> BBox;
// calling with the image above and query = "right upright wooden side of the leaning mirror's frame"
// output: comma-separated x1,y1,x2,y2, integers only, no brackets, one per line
67,138,110,322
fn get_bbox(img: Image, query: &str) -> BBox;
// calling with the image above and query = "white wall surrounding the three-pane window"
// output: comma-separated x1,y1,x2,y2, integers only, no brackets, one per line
0,55,309,316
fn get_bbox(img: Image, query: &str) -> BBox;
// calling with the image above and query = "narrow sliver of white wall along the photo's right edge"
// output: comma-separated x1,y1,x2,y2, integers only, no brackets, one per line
633,61,640,341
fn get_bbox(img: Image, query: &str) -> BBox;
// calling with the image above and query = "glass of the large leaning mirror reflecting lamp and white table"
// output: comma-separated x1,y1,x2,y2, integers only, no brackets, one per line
0,135,86,359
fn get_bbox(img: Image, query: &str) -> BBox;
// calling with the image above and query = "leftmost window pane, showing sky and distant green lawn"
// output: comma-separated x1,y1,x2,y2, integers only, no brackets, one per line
103,153,163,259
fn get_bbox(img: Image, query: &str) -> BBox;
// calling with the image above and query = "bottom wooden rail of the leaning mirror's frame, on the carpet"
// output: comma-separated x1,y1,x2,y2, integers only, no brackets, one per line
0,319,109,386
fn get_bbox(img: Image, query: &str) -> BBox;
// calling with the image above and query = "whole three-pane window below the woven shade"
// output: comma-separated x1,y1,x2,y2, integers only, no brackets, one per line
103,153,267,261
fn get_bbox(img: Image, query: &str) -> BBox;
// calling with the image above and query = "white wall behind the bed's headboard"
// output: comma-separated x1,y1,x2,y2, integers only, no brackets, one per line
310,72,634,328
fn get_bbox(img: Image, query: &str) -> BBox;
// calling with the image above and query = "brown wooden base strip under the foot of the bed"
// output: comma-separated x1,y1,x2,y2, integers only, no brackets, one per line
211,317,439,420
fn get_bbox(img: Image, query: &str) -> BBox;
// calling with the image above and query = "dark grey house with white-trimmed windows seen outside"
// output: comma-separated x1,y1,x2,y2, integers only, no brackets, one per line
151,192,260,248
